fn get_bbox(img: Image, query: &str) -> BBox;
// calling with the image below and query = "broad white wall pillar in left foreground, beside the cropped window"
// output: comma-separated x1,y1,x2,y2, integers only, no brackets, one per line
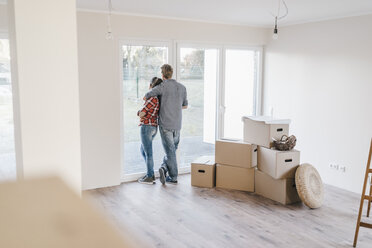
8,0,81,192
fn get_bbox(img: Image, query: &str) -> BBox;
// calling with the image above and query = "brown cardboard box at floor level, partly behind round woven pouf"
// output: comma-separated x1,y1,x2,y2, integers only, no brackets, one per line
255,169,301,205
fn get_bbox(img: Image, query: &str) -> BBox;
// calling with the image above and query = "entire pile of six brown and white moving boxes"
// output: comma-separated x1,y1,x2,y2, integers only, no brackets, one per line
191,117,300,204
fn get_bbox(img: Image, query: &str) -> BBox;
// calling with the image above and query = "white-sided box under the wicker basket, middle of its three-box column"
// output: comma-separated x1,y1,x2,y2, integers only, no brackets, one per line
258,146,300,179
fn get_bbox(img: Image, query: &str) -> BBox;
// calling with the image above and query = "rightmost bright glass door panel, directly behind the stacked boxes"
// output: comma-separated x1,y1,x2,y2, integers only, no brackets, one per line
219,48,261,139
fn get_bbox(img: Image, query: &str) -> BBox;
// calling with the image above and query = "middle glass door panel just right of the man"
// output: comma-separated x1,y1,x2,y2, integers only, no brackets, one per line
177,45,220,171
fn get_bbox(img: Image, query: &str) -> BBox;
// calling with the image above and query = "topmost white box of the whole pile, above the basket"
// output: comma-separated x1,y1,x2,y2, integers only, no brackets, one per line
242,116,291,148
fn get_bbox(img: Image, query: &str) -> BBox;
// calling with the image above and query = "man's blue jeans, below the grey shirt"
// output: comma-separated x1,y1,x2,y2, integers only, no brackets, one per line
159,126,180,180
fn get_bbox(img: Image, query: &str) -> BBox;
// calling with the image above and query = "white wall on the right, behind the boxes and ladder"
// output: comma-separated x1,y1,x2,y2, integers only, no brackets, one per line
263,15,372,193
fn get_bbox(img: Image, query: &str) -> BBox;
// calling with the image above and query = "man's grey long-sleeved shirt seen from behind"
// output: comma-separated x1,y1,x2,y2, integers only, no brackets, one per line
145,79,188,130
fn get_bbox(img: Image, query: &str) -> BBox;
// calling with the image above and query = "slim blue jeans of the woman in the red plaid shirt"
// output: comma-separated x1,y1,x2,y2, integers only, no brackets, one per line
141,125,158,177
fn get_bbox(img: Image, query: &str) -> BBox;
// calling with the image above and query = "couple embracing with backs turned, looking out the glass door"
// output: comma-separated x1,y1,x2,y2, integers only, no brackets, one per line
137,64,188,184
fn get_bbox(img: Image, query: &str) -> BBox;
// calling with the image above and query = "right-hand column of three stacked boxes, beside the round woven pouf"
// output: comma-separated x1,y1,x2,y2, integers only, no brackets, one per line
243,117,300,204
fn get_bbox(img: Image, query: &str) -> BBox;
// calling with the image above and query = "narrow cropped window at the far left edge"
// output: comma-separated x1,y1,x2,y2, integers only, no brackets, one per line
0,39,16,181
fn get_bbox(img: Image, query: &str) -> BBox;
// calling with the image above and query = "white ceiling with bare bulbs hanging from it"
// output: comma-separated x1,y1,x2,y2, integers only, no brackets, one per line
77,0,372,26
